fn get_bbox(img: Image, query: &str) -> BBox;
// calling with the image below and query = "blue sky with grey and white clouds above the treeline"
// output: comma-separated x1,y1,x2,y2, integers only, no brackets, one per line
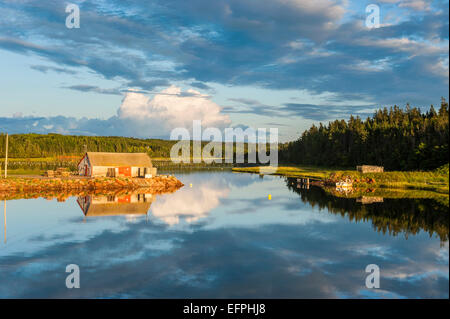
0,0,449,141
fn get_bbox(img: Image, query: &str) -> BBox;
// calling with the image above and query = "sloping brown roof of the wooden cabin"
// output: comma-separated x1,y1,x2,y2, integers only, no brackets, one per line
86,152,153,167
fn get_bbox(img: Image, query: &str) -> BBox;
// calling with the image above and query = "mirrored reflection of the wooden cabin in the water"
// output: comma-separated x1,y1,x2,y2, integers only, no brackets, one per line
77,194,154,217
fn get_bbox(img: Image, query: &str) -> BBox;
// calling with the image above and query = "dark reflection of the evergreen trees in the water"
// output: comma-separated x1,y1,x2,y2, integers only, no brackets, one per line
286,178,450,242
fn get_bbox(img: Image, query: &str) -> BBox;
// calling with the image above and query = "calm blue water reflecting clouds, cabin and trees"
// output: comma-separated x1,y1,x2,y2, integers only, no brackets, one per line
0,172,449,298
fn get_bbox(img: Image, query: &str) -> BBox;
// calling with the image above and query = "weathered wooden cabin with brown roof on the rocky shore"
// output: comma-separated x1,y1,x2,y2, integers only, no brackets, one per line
78,152,156,178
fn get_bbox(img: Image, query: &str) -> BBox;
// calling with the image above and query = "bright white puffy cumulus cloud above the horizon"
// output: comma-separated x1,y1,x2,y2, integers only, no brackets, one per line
118,86,231,133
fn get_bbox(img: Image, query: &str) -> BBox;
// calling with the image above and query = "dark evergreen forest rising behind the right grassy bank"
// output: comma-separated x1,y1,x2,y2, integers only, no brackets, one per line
279,98,449,170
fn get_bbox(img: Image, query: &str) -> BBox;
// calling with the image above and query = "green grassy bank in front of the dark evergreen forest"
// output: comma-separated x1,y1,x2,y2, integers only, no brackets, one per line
233,164,449,194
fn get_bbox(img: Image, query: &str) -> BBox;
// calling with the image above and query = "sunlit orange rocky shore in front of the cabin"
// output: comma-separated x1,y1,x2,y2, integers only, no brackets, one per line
0,175,184,199
